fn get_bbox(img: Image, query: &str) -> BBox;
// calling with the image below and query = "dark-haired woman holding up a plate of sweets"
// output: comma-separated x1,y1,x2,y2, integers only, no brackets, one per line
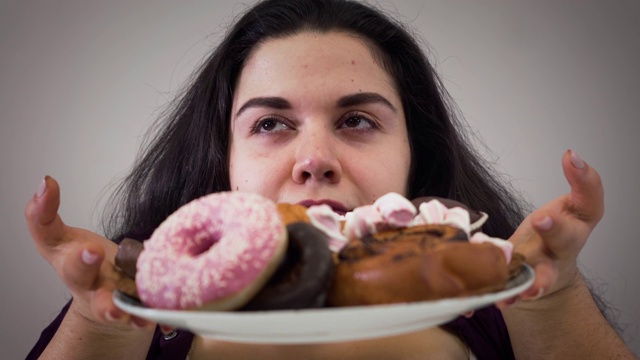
26,0,631,358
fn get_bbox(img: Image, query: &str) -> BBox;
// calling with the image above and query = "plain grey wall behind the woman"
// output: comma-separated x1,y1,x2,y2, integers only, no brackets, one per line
0,0,640,359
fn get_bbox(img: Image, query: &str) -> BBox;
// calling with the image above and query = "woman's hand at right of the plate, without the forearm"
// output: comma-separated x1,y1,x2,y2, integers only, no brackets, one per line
497,150,604,307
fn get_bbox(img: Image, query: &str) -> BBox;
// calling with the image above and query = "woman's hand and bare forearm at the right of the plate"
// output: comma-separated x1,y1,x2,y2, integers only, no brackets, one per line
498,150,636,359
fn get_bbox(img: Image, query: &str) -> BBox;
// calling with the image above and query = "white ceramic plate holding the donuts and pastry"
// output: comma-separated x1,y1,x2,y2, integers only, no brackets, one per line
113,265,534,344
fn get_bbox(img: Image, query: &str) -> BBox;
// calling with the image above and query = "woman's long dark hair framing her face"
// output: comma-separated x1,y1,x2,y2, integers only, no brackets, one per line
106,0,522,239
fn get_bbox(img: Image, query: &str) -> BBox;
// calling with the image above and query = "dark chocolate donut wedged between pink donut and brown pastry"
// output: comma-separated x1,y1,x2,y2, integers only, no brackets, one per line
240,222,334,311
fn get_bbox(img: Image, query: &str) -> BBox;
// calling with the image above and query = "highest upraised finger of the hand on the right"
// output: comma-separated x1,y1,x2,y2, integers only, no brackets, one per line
562,150,604,226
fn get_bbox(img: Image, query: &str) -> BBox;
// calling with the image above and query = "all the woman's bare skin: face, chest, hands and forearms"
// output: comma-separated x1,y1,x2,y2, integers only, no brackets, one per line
25,33,634,359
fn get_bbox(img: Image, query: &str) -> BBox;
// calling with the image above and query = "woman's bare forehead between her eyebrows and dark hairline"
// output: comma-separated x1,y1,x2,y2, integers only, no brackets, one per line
234,32,400,106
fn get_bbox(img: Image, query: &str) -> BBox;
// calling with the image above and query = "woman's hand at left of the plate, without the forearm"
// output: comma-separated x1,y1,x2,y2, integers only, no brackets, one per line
25,176,154,333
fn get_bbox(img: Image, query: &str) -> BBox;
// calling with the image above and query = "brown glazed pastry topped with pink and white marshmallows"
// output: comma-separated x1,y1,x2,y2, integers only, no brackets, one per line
329,195,522,306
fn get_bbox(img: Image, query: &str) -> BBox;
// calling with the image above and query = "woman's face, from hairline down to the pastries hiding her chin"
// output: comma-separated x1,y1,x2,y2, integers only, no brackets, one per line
229,32,410,213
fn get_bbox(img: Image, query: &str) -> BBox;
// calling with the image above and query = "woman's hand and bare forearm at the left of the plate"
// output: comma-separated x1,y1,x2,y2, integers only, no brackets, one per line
25,176,153,359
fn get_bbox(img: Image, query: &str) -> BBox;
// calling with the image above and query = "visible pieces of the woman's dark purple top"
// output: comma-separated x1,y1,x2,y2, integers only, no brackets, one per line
27,301,515,360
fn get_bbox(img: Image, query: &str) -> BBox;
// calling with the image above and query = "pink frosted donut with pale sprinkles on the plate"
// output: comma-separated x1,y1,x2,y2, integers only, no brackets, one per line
136,192,287,310
